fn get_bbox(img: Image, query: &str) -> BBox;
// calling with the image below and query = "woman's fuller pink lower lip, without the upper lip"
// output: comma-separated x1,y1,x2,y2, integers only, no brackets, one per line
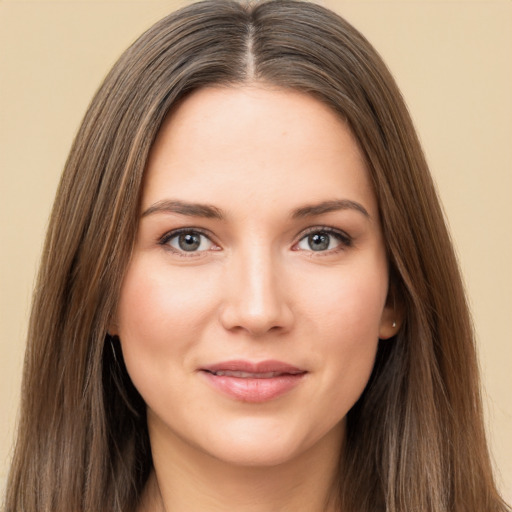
202,372,305,403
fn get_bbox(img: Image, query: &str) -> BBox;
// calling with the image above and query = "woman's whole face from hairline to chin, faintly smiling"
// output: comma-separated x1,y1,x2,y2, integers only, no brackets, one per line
112,86,395,465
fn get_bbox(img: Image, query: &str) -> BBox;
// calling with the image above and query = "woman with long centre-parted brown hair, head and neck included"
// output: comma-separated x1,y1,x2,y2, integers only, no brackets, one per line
6,1,507,512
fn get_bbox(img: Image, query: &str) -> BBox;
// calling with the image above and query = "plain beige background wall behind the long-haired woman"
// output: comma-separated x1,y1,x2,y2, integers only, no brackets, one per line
0,0,512,501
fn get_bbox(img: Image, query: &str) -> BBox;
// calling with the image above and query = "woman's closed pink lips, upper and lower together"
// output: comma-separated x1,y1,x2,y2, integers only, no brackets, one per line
201,361,307,403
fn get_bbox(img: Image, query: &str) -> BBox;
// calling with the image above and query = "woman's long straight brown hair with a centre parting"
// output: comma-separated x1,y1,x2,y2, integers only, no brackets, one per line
5,0,508,512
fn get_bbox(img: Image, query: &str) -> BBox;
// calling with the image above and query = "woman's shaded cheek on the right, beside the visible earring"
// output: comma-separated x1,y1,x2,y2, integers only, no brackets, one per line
296,261,388,402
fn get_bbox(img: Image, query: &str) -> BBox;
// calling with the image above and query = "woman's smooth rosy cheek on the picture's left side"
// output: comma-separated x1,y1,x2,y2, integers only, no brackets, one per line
117,257,222,396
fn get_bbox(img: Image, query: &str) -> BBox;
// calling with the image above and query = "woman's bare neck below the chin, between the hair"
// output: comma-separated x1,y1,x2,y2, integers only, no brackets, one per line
139,420,342,512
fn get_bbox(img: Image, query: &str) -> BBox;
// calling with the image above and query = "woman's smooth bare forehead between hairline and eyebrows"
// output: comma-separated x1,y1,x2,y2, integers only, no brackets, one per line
143,85,376,217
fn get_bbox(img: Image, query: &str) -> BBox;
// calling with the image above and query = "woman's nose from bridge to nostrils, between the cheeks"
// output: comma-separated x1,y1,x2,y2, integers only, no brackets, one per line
220,248,294,337
